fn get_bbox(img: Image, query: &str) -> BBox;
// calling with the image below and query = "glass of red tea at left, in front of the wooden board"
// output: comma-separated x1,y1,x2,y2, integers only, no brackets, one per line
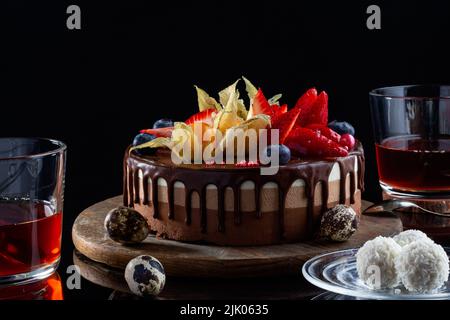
0,138,67,285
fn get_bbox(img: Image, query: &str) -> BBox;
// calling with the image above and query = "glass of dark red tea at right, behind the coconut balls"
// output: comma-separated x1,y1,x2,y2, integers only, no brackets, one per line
370,86,450,199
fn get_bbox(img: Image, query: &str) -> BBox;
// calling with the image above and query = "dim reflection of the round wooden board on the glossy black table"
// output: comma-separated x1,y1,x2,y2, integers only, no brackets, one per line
73,251,323,300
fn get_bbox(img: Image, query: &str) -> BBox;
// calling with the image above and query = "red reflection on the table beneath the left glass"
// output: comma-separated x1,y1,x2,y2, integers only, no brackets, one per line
0,273,63,300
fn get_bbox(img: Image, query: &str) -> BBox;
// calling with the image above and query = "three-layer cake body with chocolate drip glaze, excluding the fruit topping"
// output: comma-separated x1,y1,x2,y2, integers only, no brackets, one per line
124,144,364,245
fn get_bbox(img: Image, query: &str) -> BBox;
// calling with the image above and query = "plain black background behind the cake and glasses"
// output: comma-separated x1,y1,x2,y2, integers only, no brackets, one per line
0,0,450,300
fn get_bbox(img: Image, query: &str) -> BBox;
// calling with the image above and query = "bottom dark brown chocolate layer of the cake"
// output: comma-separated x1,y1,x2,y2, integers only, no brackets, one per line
135,191,361,245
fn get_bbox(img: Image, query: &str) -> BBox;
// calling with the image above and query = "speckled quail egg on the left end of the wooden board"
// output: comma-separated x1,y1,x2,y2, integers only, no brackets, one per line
105,206,150,244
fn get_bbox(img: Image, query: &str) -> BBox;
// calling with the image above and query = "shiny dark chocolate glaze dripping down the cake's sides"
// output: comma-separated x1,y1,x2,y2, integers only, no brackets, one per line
123,143,365,238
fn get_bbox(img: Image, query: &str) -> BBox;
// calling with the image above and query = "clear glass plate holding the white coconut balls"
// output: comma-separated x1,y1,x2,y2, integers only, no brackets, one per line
302,248,450,300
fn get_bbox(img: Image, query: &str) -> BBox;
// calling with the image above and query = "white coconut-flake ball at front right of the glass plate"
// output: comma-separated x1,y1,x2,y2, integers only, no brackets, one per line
395,239,449,293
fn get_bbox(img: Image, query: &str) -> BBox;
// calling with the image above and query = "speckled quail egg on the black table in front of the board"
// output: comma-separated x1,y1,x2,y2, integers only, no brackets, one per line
125,255,166,297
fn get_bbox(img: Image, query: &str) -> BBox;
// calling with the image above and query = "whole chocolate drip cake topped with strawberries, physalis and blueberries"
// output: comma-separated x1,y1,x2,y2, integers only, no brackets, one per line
123,78,364,246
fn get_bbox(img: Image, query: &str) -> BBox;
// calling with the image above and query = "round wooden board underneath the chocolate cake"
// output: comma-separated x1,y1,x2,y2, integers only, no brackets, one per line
72,196,402,278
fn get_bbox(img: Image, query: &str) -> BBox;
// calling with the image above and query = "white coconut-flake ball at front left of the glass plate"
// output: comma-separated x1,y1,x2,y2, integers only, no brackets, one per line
356,236,402,289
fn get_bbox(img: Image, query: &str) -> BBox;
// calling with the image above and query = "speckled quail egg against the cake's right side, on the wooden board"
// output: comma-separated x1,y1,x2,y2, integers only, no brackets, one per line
320,204,358,241
